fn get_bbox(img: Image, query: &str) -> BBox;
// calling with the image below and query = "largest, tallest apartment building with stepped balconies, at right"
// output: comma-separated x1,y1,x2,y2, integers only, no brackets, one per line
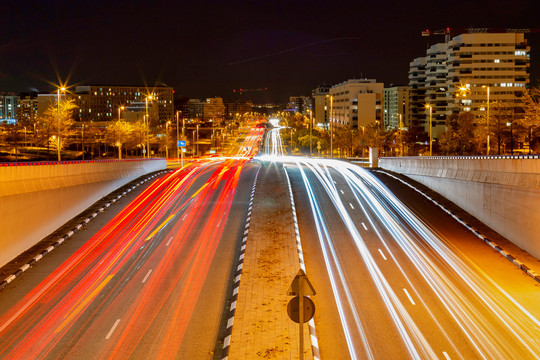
409,30,530,138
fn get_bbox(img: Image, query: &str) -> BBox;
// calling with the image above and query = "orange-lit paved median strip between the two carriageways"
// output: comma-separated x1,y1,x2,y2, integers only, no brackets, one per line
228,165,313,360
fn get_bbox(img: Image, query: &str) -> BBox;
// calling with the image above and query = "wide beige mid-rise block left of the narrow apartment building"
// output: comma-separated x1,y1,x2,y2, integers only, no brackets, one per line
330,79,384,129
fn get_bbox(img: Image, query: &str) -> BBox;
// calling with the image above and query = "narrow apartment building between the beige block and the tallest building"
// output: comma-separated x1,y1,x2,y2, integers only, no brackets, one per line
384,86,409,129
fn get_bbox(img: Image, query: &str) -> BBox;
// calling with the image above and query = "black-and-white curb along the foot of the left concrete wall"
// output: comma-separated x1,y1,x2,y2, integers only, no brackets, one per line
0,170,169,290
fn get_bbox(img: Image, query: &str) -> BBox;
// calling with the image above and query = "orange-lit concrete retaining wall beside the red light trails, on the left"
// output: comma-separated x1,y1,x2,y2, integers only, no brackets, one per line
0,159,166,266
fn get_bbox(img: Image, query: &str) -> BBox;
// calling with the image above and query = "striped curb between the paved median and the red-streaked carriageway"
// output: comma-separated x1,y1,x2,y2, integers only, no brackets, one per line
221,168,260,360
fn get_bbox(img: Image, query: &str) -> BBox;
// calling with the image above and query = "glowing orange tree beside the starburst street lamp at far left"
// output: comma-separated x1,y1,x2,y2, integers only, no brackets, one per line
39,99,77,161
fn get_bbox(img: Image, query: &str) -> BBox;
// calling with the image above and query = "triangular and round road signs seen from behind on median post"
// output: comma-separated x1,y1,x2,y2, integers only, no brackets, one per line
287,269,315,360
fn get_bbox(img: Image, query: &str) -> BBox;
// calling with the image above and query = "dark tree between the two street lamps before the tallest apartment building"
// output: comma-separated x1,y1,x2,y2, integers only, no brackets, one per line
439,112,478,155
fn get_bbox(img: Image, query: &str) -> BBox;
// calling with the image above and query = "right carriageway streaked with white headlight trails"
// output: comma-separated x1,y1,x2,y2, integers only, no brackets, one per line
263,130,540,360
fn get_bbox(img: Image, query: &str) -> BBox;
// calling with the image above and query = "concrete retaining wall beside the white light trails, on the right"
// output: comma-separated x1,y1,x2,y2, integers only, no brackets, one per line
379,156,540,258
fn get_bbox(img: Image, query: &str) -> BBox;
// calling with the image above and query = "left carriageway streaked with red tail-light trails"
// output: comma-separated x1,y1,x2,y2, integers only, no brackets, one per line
0,129,263,359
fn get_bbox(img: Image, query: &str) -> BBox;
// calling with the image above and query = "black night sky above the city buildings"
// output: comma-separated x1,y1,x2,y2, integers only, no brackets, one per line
0,0,540,102
